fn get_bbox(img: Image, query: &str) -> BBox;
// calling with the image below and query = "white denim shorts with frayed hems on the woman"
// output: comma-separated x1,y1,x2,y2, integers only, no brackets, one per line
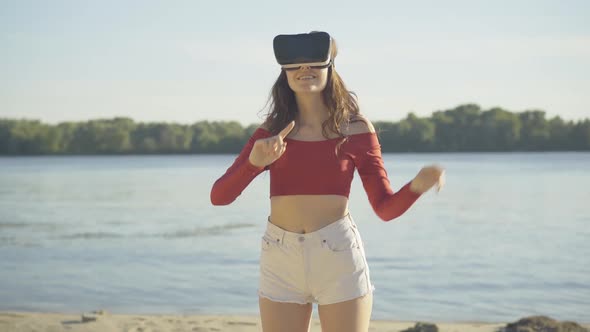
258,213,375,305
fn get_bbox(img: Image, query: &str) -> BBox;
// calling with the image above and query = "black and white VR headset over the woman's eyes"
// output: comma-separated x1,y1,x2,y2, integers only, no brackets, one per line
273,31,332,70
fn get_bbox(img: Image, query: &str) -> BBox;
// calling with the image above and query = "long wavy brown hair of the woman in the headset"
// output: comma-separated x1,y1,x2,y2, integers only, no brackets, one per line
263,31,366,152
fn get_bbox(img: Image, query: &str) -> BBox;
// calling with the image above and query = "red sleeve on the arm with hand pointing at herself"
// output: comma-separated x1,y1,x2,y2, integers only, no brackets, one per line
210,128,271,205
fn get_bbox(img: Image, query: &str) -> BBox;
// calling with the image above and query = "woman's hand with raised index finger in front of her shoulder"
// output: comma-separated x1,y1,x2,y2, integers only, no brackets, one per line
249,121,295,167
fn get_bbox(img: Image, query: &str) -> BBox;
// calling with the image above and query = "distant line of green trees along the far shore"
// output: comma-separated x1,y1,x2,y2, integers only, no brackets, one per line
0,104,590,155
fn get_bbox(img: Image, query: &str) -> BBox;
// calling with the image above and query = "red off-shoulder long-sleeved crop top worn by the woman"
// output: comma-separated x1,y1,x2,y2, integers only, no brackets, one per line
211,128,420,221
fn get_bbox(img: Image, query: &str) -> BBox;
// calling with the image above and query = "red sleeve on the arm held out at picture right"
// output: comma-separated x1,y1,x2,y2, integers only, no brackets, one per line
353,134,421,221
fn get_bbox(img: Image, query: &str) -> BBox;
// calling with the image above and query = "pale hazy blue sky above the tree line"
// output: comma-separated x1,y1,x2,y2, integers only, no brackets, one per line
0,0,590,125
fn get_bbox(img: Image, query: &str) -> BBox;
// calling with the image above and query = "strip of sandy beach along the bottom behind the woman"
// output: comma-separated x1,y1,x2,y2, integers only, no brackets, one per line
0,312,560,332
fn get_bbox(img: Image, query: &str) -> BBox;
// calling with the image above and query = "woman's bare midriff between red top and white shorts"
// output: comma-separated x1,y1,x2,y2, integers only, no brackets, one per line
269,195,348,234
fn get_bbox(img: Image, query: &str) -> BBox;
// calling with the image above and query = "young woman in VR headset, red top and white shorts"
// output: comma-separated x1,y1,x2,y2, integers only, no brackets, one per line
211,32,444,332
